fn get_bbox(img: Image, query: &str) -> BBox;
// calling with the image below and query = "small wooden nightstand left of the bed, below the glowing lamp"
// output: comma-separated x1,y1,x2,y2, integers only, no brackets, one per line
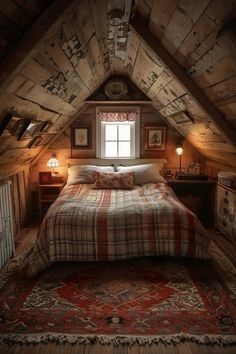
39,183,64,219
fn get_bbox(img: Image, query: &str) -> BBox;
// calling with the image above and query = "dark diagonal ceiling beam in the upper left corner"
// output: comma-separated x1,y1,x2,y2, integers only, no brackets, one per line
0,0,78,94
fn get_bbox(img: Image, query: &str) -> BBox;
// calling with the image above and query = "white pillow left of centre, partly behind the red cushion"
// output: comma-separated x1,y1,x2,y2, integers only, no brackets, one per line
67,165,115,186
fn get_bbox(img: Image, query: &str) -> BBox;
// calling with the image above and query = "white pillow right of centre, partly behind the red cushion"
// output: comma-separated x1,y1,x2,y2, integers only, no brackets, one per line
116,163,166,184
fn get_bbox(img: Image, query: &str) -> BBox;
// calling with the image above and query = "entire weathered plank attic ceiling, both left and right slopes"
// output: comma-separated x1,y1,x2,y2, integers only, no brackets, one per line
0,0,236,177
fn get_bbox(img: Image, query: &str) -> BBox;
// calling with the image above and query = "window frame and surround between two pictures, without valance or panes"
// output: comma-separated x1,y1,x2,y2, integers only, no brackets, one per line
96,106,140,159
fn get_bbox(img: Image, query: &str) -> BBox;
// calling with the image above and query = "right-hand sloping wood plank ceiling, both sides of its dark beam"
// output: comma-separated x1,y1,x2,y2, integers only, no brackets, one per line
131,0,236,168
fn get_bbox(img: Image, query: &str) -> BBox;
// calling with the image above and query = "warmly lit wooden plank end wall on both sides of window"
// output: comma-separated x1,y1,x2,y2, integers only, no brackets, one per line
31,104,204,190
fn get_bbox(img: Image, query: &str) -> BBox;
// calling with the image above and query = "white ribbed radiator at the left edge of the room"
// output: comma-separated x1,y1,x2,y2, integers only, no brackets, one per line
0,182,15,268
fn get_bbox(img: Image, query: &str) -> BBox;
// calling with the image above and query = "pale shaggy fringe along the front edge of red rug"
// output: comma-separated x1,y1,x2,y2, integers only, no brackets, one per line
0,333,236,346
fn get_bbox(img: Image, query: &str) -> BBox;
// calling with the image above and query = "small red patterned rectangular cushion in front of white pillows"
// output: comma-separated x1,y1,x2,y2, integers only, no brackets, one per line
93,172,134,189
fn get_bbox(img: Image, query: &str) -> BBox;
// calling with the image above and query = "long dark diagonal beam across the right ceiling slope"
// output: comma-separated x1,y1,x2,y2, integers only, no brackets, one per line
131,15,236,145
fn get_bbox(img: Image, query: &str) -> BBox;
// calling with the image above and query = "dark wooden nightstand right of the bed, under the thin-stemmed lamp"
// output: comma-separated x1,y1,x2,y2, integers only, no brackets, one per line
168,179,216,227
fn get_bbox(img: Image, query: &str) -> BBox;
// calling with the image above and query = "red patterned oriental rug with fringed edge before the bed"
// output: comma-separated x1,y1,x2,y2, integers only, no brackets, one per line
0,258,236,344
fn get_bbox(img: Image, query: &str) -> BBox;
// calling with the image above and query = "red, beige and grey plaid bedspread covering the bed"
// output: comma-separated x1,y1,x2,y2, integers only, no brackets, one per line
24,183,209,276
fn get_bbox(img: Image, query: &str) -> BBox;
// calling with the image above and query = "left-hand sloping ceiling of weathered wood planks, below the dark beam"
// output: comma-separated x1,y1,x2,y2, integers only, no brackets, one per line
0,0,110,178
